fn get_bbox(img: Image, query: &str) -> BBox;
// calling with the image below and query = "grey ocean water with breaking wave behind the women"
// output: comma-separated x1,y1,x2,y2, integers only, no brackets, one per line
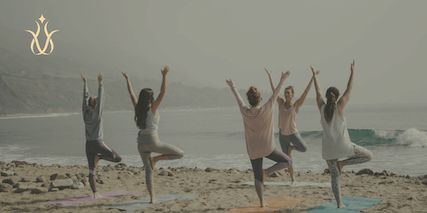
0,102,427,176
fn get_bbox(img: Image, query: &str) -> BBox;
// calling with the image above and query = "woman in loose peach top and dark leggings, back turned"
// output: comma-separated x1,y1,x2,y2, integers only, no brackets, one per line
226,71,292,207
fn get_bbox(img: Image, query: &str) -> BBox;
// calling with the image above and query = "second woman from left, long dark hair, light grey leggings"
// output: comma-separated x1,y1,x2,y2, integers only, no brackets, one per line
122,66,184,203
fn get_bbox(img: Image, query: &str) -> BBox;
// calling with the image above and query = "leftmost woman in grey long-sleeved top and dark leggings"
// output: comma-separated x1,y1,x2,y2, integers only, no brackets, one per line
81,73,122,198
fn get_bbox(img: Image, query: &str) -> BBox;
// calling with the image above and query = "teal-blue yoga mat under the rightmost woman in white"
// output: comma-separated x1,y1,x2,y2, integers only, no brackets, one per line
308,197,384,213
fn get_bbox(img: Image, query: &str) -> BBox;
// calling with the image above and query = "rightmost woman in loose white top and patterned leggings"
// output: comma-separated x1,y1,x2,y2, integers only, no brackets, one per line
311,60,373,208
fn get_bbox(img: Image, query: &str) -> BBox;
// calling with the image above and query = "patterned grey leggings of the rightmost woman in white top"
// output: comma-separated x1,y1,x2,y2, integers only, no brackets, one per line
326,144,373,206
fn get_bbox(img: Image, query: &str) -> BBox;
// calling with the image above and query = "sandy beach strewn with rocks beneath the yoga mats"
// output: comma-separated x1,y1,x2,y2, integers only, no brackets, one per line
0,162,427,213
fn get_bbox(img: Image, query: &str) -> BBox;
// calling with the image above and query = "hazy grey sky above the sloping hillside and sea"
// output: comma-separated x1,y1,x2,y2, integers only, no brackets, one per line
0,0,427,103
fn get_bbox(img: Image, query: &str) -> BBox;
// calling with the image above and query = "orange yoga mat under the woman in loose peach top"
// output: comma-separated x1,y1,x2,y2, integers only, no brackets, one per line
226,197,307,213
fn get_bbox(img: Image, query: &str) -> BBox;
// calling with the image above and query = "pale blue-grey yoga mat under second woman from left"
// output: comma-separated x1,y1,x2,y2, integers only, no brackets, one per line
102,193,199,211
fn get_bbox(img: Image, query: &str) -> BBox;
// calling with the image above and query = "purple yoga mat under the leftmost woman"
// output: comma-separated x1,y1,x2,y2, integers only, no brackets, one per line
48,191,141,206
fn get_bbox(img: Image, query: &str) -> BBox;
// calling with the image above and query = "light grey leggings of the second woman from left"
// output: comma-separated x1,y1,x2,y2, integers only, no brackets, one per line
138,133,184,184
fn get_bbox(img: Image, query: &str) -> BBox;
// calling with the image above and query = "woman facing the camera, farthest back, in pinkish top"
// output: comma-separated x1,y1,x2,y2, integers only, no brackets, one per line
264,69,319,185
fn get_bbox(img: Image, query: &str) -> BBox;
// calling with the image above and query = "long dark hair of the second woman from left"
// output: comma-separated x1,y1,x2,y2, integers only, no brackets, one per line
134,88,154,129
